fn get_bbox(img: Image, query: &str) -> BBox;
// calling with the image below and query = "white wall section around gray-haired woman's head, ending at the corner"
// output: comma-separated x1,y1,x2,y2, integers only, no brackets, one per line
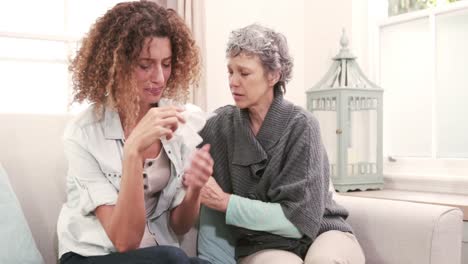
205,0,305,110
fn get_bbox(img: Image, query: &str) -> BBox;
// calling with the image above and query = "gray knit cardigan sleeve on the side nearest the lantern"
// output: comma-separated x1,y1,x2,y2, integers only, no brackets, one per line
267,116,329,239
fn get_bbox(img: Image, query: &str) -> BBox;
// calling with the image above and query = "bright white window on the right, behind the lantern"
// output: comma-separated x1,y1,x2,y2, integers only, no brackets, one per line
375,1,468,179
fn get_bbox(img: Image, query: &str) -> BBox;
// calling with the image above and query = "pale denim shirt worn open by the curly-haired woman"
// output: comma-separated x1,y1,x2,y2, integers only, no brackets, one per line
57,99,189,256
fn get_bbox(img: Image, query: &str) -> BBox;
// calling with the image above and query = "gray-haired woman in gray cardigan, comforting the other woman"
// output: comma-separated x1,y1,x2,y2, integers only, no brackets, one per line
198,24,364,264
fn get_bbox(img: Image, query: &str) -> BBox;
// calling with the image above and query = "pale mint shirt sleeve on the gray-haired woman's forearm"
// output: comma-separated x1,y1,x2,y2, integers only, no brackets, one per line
226,194,302,238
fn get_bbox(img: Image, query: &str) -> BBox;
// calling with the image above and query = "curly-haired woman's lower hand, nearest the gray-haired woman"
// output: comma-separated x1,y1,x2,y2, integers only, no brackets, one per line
183,144,214,192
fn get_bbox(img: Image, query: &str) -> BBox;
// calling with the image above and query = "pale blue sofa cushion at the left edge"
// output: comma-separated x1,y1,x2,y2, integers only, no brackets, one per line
0,164,44,263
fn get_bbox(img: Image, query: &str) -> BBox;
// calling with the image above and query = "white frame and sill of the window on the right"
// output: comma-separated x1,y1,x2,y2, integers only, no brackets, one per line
369,1,468,190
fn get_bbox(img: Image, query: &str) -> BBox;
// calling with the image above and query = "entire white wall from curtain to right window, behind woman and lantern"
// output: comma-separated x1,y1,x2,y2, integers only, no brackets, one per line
205,0,368,110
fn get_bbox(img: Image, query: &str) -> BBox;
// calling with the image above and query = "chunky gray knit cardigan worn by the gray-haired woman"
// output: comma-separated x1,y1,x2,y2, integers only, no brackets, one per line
201,91,352,258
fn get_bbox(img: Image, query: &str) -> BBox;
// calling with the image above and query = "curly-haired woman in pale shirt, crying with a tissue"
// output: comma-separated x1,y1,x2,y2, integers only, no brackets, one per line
57,1,213,264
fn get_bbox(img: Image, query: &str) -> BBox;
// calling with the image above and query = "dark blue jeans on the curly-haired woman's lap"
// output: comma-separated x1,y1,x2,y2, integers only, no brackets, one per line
60,246,210,264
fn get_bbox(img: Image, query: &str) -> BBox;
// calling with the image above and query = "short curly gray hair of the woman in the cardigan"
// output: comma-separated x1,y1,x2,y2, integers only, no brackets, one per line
226,24,293,92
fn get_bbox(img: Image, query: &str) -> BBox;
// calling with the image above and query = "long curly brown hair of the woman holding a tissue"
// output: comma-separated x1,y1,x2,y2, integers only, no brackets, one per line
69,1,200,129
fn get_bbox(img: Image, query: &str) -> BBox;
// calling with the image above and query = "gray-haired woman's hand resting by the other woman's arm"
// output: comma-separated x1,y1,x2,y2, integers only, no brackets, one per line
201,177,231,213
